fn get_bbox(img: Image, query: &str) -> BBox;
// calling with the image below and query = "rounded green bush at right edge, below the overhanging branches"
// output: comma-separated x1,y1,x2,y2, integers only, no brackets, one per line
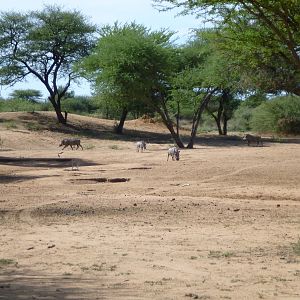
250,96,300,134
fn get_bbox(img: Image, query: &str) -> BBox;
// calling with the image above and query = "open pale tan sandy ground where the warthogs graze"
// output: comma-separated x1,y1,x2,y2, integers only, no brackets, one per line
0,114,300,300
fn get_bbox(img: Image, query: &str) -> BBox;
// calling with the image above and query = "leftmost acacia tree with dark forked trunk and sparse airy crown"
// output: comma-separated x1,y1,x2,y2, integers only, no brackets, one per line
0,6,96,124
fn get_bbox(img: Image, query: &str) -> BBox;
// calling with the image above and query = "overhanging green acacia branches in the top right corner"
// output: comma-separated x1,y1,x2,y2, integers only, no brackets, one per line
153,0,300,95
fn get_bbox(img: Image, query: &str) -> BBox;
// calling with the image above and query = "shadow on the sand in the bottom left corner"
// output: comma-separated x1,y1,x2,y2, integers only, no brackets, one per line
0,270,135,300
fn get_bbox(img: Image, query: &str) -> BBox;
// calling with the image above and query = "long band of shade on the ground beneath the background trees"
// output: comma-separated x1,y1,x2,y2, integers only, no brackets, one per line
8,112,300,147
